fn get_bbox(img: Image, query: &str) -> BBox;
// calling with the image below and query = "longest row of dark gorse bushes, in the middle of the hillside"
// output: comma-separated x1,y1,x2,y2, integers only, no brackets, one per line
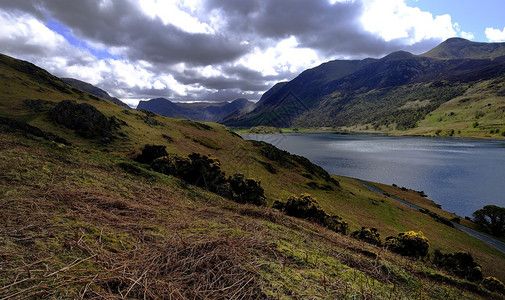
151,153,266,205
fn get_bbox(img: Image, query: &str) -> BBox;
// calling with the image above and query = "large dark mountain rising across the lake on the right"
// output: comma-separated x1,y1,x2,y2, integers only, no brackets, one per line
223,39,505,137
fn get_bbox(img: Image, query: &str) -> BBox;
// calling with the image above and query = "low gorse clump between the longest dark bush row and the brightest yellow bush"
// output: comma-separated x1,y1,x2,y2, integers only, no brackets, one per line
273,194,349,234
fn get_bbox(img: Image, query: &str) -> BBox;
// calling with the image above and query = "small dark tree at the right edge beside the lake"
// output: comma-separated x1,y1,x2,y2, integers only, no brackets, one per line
473,205,505,237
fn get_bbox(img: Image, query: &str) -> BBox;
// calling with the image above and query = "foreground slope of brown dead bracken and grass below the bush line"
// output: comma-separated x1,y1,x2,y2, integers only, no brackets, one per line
0,134,496,299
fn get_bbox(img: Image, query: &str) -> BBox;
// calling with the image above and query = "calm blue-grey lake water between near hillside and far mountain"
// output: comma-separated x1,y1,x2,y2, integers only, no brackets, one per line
243,133,505,216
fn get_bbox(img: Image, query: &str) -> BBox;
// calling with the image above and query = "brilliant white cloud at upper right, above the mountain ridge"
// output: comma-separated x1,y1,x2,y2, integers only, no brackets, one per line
361,0,456,45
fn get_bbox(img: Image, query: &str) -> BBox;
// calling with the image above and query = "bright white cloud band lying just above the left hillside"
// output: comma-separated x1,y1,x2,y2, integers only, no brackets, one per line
0,9,193,105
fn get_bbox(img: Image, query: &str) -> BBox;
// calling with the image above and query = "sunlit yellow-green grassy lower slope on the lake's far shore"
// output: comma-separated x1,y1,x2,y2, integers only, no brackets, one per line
341,77,505,139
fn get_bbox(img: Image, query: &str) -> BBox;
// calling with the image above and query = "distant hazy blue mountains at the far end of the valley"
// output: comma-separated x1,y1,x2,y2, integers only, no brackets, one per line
137,98,254,122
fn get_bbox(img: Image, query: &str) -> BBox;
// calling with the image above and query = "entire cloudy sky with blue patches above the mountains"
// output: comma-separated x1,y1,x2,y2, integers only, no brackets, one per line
0,0,505,106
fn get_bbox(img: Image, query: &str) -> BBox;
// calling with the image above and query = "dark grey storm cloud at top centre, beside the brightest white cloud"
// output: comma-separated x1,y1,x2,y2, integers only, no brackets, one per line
206,0,440,57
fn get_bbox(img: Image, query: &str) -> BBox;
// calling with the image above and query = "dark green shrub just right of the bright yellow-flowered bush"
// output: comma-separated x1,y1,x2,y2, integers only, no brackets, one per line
433,250,482,281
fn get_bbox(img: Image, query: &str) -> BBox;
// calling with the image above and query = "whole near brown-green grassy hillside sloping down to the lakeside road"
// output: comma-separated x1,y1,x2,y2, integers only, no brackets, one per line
0,52,505,299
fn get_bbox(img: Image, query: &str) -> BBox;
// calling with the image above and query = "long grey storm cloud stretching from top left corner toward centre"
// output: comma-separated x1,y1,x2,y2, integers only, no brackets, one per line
3,0,248,65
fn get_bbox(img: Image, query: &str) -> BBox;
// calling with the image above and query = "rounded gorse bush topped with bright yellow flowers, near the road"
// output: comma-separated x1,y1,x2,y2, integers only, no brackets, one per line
385,231,430,258
